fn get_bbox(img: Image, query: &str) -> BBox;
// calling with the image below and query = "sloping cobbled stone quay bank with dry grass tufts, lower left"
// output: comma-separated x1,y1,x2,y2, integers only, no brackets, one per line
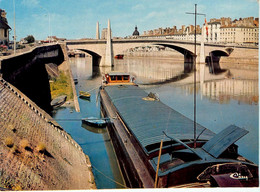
0,77,96,190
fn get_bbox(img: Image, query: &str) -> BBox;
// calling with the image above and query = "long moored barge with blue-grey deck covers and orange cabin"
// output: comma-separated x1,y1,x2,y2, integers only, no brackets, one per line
100,73,259,188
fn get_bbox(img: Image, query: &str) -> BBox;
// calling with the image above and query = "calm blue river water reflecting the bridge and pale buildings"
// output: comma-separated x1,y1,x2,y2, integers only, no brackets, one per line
50,57,259,189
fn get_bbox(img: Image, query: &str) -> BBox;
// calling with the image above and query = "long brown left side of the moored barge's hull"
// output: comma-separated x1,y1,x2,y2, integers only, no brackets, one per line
100,90,154,188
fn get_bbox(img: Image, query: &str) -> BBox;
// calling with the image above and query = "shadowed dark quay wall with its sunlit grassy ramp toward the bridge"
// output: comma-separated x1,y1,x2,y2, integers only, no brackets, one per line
0,44,79,113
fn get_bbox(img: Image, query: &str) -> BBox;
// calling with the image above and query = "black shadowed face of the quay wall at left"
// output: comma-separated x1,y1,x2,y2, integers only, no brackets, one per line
0,44,64,112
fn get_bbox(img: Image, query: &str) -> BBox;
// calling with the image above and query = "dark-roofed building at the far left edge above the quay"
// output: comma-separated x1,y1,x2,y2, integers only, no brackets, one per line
0,9,11,46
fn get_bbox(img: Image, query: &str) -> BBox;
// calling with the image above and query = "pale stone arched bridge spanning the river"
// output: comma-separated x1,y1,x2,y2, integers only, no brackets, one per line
66,38,234,67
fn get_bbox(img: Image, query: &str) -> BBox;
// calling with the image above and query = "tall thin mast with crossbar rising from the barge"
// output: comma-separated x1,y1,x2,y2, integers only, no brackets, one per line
186,4,206,148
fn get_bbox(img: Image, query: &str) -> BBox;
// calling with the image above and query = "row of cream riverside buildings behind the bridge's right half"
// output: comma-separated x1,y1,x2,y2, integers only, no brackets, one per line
139,17,259,45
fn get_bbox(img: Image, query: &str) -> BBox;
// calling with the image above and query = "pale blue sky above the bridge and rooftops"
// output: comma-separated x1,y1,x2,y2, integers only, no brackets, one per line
0,0,259,40
